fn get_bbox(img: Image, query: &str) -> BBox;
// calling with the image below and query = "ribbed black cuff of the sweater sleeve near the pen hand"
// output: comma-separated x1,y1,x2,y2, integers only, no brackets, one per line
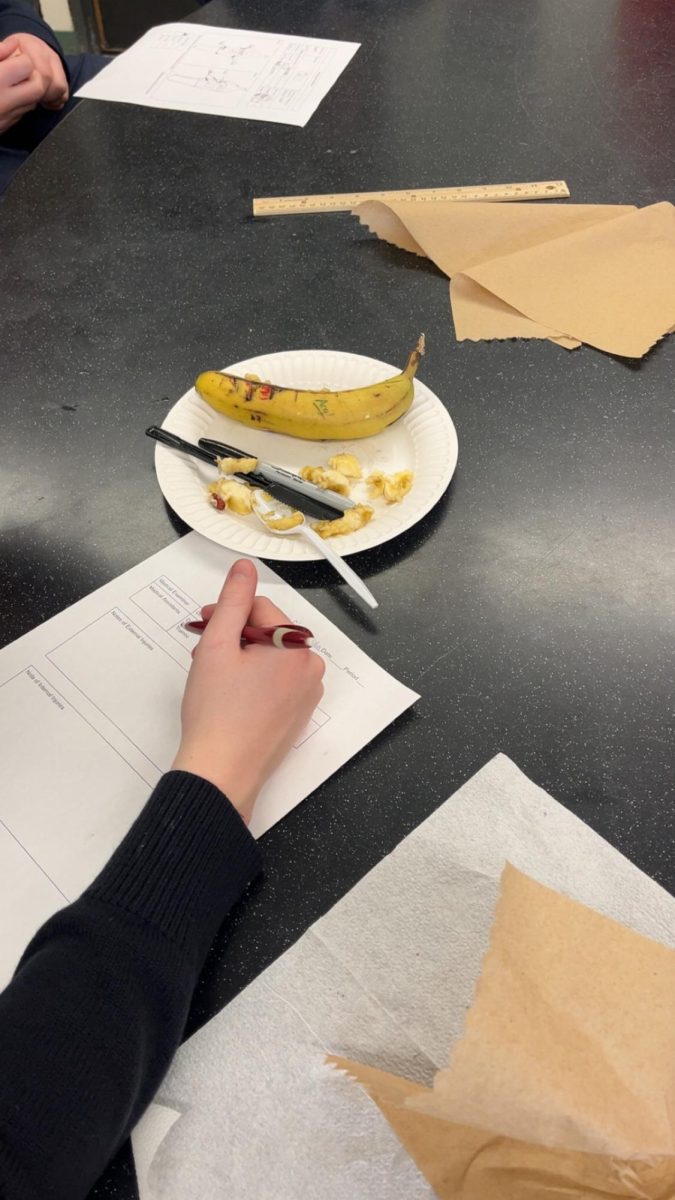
84,770,262,954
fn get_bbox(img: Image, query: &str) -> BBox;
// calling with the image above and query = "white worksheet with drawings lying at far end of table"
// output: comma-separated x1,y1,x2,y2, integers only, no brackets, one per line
77,23,359,125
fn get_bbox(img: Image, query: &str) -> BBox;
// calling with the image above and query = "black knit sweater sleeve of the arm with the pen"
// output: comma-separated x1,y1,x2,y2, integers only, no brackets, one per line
0,772,259,1200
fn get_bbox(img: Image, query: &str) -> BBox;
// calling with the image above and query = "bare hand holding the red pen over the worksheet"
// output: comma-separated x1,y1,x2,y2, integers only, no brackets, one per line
173,559,324,821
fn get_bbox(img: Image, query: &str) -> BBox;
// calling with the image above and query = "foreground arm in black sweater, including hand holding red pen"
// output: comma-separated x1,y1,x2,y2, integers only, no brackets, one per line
0,562,323,1200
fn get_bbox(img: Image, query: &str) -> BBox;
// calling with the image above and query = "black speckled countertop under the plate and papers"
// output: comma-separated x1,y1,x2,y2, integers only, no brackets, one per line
0,0,675,1200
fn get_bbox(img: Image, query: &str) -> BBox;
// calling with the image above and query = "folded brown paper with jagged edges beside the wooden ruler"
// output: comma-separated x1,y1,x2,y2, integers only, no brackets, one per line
354,200,675,358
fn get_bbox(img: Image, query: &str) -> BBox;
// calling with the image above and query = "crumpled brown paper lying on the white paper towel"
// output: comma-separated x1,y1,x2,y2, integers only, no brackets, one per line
329,866,675,1200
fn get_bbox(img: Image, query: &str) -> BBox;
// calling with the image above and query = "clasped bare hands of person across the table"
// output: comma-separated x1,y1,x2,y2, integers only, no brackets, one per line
0,34,68,133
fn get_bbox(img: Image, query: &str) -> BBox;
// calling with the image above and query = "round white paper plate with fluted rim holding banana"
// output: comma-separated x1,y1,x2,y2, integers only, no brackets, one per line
155,350,458,563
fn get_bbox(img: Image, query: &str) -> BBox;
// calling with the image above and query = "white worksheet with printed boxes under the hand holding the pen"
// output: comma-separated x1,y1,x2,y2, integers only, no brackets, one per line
0,533,418,986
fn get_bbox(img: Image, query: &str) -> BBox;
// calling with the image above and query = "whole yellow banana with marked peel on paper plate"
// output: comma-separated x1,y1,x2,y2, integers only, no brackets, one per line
195,334,424,442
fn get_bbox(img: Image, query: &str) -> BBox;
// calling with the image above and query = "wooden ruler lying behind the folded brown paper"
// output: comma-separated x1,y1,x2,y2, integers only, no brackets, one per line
253,179,569,217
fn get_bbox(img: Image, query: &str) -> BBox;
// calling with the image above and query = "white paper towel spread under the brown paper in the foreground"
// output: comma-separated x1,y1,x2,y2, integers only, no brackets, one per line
135,755,675,1200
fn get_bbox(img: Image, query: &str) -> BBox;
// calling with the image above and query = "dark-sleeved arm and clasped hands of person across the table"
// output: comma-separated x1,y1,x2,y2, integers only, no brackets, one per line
0,0,70,136
